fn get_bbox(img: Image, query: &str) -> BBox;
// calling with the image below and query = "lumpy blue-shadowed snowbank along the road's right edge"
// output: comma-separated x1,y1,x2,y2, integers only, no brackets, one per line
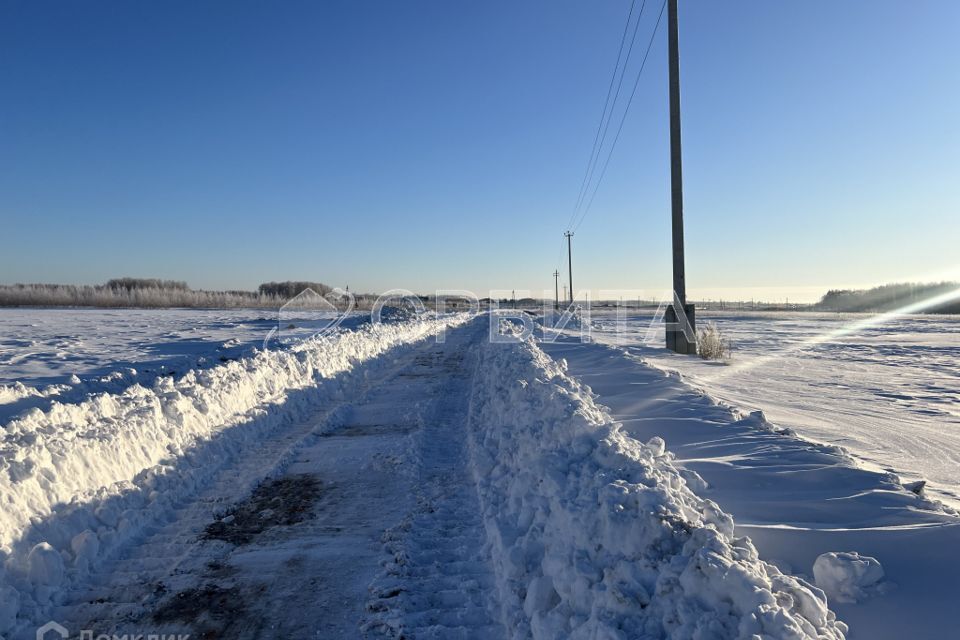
470,342,847,640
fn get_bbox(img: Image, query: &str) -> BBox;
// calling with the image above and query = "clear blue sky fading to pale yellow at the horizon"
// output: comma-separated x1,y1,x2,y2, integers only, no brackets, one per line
0,0,960,301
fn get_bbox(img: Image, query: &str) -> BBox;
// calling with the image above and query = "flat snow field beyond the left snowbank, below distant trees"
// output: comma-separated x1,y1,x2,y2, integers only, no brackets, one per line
0,308,364,424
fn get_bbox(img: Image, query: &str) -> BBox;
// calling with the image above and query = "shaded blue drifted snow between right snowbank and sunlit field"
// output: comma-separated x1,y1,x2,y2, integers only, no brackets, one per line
542,320,960,640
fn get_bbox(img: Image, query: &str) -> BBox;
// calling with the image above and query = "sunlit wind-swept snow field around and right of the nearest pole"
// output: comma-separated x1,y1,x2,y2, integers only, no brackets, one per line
594,311,960,507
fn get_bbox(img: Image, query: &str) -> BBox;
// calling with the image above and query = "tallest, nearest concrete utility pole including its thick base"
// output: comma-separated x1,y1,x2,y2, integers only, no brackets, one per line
666,0,697,354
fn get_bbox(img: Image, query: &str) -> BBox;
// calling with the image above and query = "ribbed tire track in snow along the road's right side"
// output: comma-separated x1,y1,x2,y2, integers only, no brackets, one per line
364,325,505,640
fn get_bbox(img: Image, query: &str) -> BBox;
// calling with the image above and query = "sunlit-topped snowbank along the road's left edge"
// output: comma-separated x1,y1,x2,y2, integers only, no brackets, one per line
0,314,471,635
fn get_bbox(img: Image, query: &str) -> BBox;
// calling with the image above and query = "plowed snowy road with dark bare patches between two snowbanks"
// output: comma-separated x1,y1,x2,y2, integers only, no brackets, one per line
49,323,503,638
